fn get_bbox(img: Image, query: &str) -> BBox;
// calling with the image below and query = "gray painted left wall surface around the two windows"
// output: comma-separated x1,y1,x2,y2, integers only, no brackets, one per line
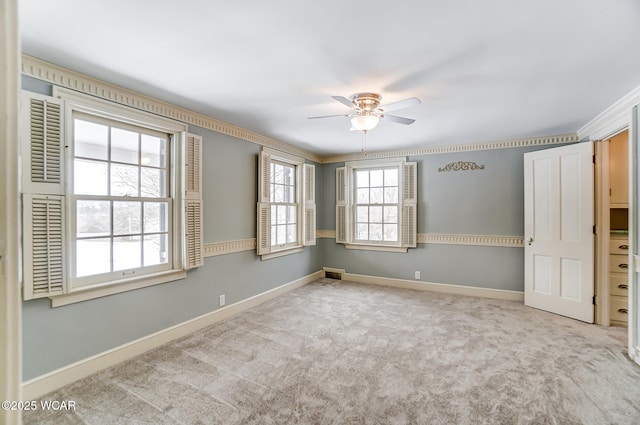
22,78,322,381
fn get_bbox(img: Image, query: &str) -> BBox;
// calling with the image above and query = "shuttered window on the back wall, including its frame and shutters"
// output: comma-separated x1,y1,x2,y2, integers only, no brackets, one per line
336,160,417,251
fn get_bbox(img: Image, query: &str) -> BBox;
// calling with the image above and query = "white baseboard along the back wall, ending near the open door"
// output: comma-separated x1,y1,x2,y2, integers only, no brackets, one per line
342,273,524,302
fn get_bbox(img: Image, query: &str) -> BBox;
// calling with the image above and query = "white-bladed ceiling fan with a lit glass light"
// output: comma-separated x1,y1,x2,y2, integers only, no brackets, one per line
308,93,422,133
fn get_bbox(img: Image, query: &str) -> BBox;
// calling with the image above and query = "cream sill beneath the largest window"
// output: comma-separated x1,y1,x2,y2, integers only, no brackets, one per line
49,270,187,307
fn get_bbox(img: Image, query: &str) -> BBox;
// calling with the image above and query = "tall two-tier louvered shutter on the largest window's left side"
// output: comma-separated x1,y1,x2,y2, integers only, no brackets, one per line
21,92,67,300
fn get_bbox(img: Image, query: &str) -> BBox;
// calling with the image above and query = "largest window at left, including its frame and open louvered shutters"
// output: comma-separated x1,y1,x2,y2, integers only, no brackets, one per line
23,88,202,305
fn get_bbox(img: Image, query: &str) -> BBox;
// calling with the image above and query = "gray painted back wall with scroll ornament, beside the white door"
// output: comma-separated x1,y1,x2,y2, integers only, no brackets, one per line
320,147,560,291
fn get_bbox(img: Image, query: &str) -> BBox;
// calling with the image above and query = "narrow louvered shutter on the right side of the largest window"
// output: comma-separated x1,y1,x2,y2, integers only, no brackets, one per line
184,134,204,270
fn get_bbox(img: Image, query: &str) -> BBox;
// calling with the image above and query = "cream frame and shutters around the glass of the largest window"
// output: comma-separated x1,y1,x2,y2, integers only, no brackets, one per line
21,85,198,307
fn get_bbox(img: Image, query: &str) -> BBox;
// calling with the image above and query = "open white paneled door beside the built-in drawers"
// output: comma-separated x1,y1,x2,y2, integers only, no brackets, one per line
524,142,595,323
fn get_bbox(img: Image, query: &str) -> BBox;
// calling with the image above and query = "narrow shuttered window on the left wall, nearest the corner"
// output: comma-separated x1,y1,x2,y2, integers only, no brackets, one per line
257,148,316,259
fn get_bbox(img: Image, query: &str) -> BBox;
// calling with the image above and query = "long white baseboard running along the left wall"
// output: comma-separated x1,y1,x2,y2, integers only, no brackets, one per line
22,270,324,400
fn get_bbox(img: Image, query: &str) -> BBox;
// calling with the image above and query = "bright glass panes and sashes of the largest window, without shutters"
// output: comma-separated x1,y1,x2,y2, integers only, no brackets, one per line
71,113,173,283
